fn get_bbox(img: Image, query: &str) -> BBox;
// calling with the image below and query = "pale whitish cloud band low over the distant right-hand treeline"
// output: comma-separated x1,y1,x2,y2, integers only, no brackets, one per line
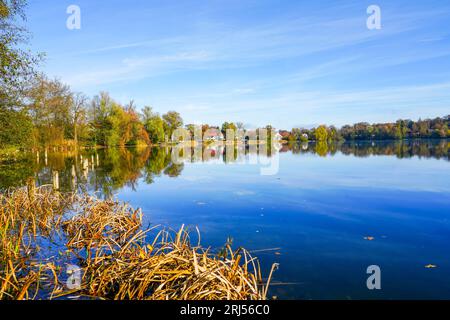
159,82,450,127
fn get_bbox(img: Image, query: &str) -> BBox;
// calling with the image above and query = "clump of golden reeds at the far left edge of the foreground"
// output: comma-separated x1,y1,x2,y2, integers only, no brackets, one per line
0,188,73,299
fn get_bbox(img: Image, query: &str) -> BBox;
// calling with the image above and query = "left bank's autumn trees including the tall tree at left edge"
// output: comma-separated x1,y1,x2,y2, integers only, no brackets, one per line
0,0,183,149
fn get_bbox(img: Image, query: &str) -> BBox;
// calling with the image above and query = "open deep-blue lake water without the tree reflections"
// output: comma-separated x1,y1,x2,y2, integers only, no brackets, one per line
3,142,450,299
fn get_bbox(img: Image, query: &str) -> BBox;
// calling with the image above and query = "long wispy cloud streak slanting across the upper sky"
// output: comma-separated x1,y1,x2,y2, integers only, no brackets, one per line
63,6,450,86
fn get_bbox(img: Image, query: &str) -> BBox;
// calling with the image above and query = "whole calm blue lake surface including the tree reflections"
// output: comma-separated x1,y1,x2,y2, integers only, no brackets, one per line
0,140,450,299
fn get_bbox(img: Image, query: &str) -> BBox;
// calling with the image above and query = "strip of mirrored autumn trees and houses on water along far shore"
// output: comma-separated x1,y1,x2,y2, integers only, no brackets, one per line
0,140,450,192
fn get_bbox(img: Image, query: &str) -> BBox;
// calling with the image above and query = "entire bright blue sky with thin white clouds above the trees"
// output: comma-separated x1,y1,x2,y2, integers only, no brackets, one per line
27,0,450,128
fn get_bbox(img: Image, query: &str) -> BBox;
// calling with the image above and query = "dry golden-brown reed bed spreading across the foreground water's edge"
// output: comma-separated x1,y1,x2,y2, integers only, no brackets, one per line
0,187,276,300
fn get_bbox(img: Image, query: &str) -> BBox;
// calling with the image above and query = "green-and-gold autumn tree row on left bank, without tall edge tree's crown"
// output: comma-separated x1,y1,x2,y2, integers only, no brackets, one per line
0,75,183,148
